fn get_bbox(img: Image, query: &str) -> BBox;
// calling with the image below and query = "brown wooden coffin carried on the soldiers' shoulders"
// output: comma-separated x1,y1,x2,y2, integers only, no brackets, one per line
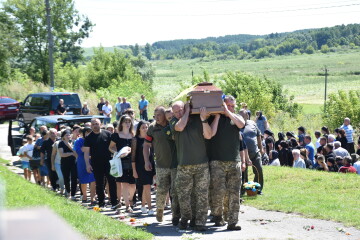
188,82,224,114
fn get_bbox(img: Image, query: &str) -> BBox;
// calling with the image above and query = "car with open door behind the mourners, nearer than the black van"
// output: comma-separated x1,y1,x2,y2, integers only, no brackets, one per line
8,115,104,156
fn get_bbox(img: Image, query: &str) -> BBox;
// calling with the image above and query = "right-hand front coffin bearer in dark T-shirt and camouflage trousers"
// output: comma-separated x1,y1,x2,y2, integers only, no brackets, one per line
209,96,246,230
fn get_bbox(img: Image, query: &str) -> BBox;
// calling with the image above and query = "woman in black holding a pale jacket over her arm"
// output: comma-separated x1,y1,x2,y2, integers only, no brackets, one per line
109,115,136,213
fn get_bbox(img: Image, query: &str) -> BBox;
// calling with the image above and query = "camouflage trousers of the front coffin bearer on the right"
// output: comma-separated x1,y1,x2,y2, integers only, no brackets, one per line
210,160,241,224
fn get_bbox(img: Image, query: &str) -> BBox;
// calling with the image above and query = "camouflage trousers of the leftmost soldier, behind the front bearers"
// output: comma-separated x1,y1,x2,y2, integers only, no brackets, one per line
156,168,180,218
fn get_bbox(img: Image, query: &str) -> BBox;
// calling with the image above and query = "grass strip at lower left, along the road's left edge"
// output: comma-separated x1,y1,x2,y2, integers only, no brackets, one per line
0,159,153,239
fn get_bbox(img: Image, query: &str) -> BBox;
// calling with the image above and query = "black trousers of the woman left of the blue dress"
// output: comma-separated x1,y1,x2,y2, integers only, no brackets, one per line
61,158,77,197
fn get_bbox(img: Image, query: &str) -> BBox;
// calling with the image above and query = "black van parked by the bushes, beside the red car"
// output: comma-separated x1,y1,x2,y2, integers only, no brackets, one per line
17,92,81,123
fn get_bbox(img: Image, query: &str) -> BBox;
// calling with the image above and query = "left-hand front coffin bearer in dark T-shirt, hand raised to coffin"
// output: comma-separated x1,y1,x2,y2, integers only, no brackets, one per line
170,101,212,231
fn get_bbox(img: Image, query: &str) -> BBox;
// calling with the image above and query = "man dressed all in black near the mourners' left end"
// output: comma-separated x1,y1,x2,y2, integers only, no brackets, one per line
40,128,58,191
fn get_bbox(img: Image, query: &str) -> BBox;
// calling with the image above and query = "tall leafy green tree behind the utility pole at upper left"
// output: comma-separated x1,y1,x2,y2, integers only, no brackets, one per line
3,0,93,84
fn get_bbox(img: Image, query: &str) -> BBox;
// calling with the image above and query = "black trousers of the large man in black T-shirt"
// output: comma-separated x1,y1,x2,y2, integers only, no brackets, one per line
91,162,118,206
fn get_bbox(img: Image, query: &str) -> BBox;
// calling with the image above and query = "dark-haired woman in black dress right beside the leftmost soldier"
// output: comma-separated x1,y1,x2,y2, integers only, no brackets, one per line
131,121,155,216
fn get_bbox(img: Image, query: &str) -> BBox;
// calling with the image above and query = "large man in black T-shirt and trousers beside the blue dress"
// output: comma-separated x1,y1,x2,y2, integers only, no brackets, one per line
83,118,118,209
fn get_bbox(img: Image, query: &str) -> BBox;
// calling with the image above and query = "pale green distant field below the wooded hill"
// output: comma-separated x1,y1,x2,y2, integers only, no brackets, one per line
152,50,360,105
